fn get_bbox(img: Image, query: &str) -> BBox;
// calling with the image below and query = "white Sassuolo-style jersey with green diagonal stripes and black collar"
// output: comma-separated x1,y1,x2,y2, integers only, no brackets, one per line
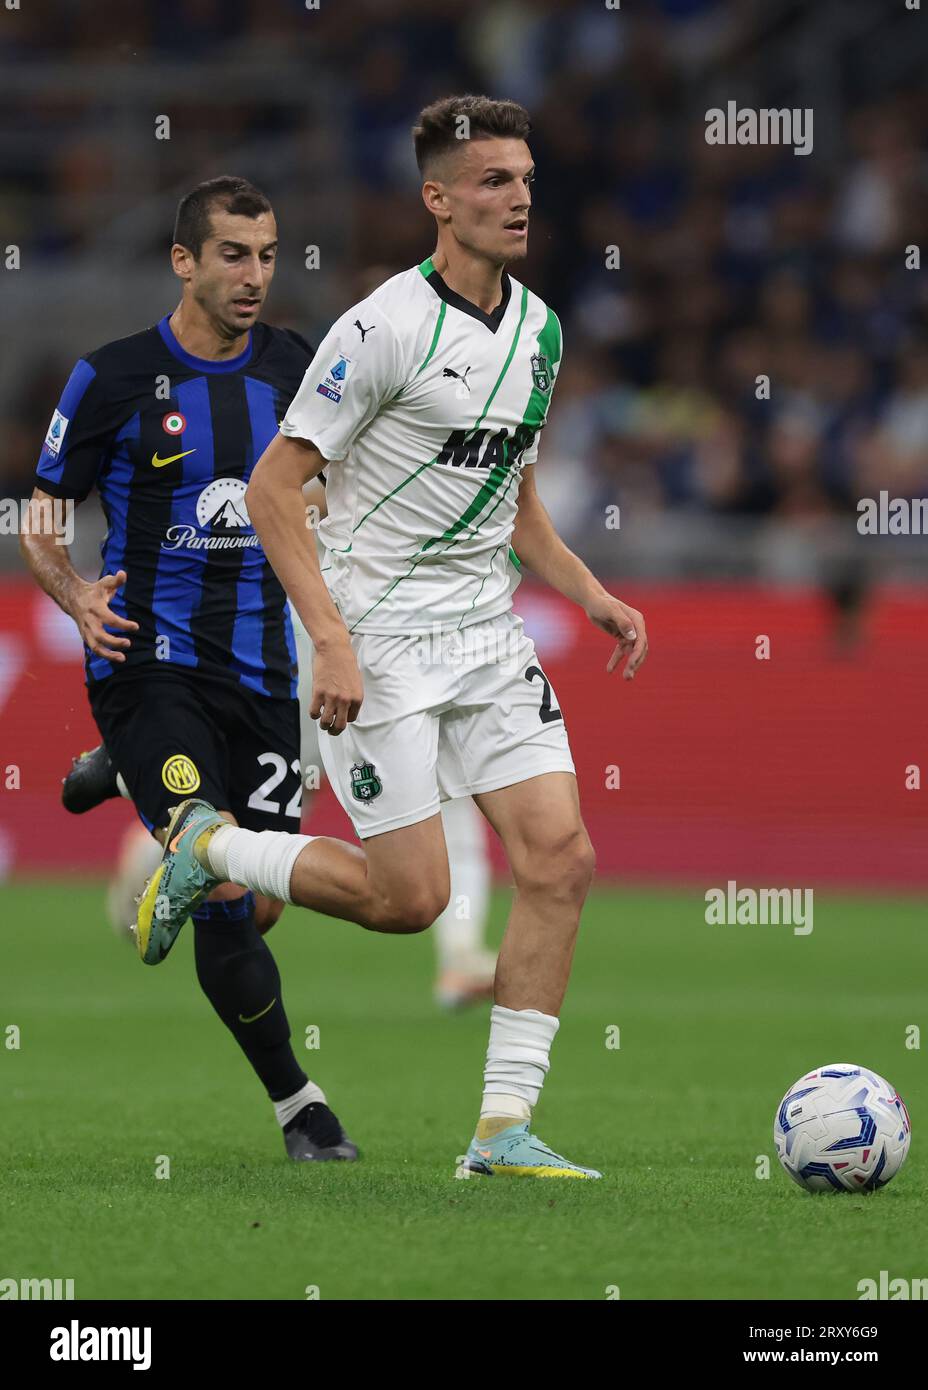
281,259,561,634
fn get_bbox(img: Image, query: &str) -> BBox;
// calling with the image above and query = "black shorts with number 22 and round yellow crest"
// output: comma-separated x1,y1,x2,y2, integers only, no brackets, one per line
88,666,303,833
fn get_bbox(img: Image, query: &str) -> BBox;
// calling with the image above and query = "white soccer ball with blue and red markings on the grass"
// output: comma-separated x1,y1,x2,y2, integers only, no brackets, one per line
774,1062,911,1193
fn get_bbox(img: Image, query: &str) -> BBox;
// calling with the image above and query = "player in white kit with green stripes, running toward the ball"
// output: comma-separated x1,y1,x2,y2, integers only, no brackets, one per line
139,96,647,1179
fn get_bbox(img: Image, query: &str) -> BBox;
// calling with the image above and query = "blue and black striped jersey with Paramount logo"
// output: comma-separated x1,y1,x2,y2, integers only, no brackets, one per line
35,316,313,696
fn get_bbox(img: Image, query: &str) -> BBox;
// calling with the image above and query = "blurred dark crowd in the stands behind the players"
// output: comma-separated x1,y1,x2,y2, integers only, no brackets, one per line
0,0,928,581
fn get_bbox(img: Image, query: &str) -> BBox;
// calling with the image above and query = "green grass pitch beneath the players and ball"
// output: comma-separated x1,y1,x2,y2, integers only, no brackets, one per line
0,884,928,1300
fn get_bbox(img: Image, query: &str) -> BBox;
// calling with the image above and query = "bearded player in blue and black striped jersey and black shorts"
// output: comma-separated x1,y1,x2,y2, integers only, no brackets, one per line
22,178,357,1159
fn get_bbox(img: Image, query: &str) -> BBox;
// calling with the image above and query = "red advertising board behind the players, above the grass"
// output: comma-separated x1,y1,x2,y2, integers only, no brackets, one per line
0,578,928,888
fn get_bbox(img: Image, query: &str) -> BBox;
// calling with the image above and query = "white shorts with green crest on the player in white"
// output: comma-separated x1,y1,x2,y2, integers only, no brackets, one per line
313,613,574,840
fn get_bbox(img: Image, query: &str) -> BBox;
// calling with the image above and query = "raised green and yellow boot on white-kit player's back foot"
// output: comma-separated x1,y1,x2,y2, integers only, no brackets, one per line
135,796,228,965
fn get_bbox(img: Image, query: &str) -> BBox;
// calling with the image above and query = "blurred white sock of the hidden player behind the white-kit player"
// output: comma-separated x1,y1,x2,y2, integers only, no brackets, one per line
432,796,490,970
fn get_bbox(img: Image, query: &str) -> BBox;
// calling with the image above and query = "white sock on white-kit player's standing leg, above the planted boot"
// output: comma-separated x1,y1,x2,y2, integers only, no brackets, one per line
481,1004,560,1120
